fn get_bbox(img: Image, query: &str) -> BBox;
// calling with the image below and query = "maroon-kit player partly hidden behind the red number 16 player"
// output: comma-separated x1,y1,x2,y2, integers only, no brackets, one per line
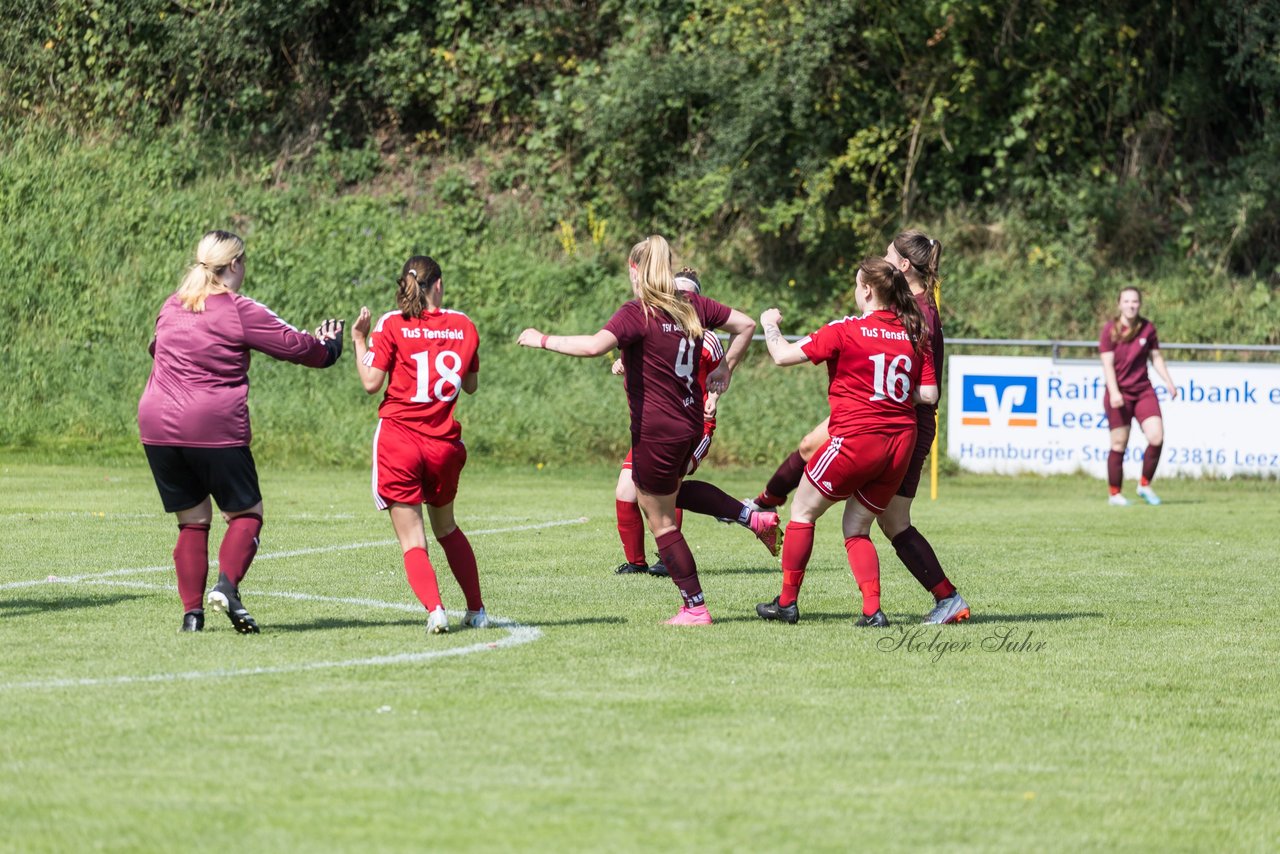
751,230,970,625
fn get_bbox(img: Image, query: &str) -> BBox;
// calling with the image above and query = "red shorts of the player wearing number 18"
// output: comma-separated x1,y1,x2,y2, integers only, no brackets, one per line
374,419,467,510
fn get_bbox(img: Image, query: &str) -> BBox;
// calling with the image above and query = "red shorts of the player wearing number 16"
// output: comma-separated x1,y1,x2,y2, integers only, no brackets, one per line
804,428,915,515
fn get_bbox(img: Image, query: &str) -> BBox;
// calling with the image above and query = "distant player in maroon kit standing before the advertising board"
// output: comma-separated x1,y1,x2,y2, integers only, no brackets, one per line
1098,288,1178,507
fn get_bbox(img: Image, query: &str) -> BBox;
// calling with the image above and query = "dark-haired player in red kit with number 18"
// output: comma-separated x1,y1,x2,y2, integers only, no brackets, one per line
351,255,489,634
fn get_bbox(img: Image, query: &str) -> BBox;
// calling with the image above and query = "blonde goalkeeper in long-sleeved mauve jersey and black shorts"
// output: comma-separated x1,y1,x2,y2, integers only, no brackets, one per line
138,232,342,634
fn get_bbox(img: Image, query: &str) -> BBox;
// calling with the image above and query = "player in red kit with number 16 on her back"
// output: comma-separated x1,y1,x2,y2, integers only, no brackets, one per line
755,257,938,626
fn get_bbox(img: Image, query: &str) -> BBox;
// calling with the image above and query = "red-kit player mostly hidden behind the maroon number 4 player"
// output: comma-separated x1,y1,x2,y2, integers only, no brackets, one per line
613,266,724,577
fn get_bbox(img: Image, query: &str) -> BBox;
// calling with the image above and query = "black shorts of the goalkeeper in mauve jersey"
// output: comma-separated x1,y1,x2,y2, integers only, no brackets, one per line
142,444,262,513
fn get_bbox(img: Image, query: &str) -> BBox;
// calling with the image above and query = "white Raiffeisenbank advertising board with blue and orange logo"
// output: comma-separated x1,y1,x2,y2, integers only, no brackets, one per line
947,355,1280,479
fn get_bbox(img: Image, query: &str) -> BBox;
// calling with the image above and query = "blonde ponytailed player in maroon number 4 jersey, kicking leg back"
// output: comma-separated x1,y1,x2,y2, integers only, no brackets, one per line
518,234,778,626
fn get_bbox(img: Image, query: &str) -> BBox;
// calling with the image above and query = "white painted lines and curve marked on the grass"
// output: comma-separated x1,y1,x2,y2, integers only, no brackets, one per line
0,516,588,691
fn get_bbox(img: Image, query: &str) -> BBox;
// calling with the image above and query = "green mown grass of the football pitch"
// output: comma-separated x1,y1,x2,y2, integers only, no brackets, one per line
0,463,1280,851
